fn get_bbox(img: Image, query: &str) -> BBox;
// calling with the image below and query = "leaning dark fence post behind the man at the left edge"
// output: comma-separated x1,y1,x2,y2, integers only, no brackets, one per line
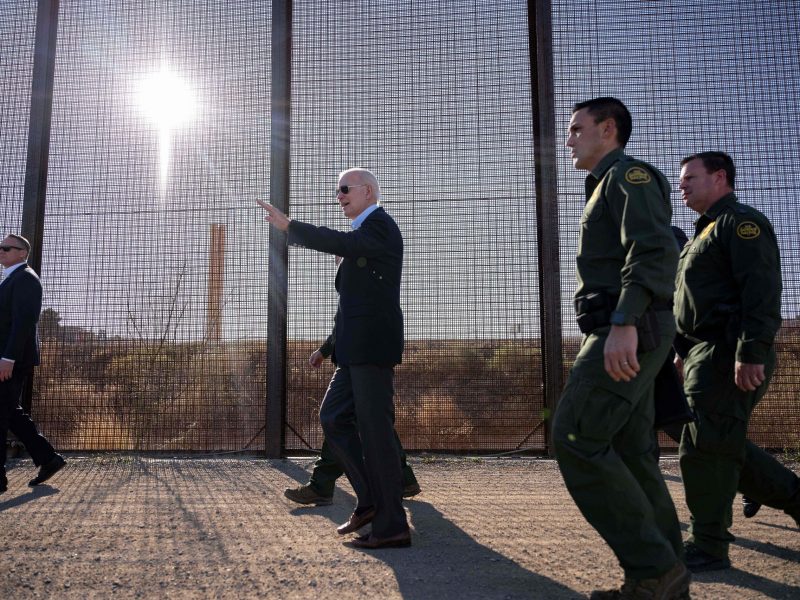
20,0,58,412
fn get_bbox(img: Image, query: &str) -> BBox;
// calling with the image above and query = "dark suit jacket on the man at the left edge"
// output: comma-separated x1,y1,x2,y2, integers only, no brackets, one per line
0,265,42,368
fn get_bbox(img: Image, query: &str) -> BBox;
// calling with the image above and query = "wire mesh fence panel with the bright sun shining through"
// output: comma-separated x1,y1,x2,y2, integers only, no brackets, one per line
35,0,270,450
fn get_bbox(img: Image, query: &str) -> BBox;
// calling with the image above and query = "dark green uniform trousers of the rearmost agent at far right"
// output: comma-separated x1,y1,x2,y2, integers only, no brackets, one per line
679,342,800,557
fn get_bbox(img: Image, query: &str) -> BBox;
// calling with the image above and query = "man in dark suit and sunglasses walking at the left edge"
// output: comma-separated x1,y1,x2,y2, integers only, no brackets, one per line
0,234,65,494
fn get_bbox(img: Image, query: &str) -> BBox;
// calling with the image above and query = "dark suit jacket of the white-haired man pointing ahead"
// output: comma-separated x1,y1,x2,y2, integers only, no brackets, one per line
289,208,403,367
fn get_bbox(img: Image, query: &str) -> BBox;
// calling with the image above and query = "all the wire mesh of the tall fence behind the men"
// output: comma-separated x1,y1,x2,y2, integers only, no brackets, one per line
0,0,800,451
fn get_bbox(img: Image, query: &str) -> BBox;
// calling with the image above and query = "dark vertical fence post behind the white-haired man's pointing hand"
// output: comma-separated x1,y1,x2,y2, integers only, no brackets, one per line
265,0,292,458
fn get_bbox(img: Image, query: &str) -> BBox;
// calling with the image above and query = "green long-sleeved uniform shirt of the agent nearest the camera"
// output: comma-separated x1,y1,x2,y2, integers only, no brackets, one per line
575,148,678,324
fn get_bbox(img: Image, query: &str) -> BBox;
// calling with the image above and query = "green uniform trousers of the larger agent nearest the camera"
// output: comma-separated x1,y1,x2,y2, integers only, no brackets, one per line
553,318,683,579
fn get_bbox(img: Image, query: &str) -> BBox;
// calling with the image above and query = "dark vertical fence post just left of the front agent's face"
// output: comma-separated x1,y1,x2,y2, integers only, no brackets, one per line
528,0,564,455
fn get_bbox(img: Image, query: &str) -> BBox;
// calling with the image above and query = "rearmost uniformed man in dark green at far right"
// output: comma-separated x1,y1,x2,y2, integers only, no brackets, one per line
675,152,800,572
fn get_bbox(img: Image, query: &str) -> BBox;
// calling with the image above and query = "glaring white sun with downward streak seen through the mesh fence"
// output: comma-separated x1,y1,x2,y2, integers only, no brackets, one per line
137,66,197,191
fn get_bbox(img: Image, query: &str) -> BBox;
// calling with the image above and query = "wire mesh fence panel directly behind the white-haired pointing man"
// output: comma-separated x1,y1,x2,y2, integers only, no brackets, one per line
287,0,543,450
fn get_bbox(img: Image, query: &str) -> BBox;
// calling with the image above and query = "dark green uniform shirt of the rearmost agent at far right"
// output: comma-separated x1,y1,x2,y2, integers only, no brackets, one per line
675,193,781,364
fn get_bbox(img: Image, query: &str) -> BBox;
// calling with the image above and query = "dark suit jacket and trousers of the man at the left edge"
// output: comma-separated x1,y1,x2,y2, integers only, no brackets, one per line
0,265,55,471
